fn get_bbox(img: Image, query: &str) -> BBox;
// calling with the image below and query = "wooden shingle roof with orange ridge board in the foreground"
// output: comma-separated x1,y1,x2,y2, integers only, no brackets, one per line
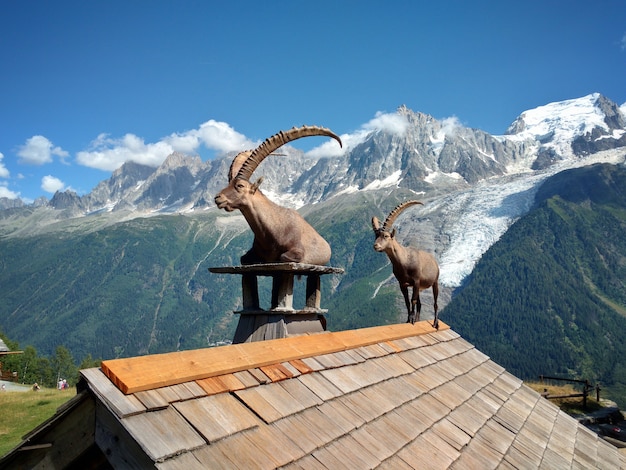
81,322,626,470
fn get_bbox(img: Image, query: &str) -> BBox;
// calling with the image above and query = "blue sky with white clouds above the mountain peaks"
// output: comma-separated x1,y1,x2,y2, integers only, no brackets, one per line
0,0,626,202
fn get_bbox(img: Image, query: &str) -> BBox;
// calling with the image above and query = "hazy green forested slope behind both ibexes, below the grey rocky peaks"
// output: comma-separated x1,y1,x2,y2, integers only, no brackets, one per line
0,190,427,359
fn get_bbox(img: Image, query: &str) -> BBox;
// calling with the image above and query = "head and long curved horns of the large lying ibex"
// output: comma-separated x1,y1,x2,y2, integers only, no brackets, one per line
215,126,342,212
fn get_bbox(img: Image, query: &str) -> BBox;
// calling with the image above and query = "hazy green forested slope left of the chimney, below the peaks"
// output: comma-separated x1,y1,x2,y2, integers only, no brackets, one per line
0,216,243,358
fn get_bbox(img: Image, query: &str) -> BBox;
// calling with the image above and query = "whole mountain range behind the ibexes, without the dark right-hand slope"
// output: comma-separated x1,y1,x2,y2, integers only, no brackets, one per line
0,93,626,400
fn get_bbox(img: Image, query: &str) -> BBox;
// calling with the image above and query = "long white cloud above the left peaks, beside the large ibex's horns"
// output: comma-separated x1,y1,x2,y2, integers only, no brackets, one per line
76,120,255,171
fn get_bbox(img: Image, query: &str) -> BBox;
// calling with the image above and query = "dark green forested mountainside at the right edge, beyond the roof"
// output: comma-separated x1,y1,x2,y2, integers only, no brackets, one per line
442,165,626,407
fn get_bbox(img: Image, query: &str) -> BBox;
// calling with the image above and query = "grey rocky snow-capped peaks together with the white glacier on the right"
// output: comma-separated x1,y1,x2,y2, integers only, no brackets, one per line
0,93,626,288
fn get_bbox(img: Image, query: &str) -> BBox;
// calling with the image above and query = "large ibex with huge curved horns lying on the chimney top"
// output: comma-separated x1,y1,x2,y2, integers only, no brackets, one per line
215,126,342,266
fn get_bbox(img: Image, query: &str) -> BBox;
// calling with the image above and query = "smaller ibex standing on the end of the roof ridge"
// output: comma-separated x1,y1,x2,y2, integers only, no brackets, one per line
372,201,439,328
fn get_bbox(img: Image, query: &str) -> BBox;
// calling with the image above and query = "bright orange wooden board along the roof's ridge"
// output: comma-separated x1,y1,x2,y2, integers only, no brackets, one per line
101,321,449,394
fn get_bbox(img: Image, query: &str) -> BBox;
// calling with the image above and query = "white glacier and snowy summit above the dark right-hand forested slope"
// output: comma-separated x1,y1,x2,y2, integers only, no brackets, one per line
425,93,626,287
